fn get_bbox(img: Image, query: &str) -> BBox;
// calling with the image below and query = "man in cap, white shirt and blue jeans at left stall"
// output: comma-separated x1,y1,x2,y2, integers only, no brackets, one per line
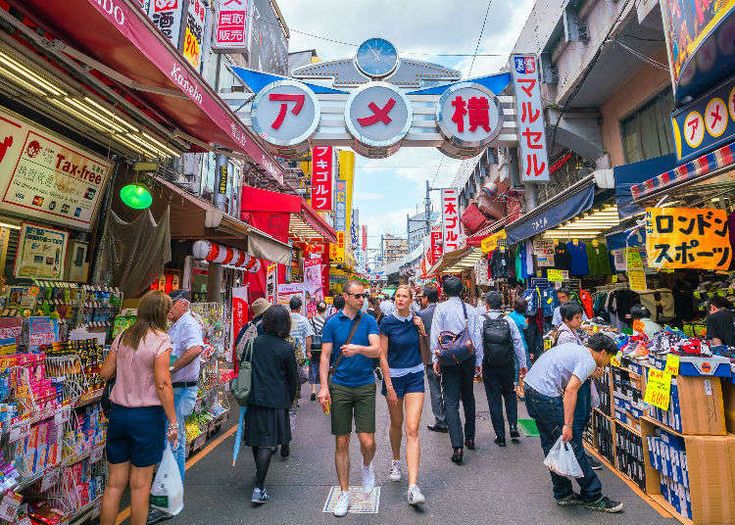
168,290,204,481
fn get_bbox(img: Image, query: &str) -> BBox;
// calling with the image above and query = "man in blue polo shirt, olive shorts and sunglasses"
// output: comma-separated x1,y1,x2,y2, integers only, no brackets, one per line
319,281,380,516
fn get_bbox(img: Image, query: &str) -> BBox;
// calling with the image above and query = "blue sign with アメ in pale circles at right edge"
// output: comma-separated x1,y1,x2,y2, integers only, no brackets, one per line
671,73,735,161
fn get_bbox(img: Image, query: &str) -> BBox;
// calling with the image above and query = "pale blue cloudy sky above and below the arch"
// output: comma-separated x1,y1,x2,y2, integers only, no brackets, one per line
277,0,533,254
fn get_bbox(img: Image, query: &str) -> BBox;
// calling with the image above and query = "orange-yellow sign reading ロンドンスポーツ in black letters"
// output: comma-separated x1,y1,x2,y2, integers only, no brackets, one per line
646,208,732,270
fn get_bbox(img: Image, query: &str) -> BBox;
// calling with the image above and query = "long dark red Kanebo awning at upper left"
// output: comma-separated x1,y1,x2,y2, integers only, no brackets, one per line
17,0,285,185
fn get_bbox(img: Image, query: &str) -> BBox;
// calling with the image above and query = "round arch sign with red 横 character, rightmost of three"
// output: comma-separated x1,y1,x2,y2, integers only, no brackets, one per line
435,82,506,154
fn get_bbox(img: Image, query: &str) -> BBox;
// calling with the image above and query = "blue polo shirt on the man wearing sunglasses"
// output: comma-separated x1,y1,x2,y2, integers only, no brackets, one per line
322,310,378,388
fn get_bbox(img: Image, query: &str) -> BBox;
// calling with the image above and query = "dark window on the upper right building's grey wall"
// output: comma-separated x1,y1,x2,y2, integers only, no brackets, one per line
620,89,674,163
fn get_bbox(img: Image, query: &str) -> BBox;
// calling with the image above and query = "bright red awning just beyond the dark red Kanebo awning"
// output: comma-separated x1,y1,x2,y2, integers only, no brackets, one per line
240,186,337,242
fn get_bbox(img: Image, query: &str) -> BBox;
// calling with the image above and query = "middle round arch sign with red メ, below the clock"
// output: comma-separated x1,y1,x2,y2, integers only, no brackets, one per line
345,82,413,158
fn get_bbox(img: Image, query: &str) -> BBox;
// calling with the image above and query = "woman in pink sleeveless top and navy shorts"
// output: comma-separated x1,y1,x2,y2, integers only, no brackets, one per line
100,291,178,525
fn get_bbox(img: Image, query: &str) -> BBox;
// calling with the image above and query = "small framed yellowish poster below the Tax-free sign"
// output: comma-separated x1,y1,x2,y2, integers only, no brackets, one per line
15,223,69,281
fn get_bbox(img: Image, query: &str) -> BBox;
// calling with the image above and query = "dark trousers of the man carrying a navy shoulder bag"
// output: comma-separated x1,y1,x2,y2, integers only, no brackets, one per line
441,357,476,448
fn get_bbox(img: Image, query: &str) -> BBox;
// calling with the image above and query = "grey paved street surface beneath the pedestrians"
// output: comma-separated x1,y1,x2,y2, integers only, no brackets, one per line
168,385,675,525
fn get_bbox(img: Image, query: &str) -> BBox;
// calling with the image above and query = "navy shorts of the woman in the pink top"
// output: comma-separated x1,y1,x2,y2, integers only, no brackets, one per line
105,403,166,468
